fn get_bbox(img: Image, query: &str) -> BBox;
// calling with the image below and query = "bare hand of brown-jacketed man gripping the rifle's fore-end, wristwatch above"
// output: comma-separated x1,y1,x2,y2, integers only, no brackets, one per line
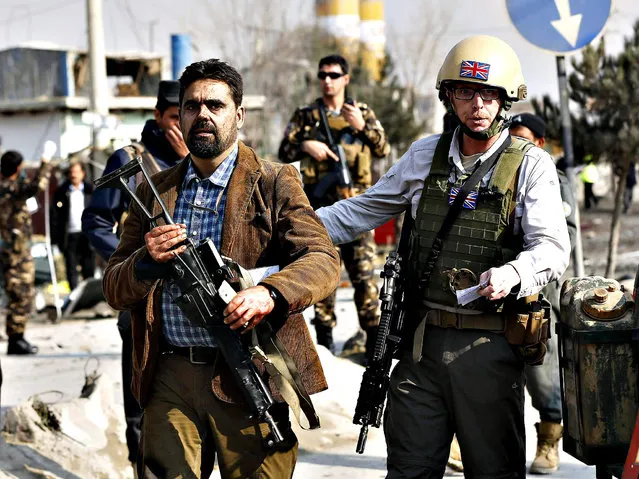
224,285,275,333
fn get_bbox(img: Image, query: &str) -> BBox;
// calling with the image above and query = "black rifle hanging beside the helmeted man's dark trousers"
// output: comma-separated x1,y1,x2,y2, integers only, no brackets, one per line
353,252,404,454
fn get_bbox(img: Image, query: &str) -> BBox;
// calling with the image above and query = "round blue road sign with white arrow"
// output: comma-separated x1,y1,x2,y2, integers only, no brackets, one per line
506,0,612,54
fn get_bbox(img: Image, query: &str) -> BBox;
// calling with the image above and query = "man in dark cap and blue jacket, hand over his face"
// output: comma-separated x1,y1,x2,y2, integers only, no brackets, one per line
82,81,189,470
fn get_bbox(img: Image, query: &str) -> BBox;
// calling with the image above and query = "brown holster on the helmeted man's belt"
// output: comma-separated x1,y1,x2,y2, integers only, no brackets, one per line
504,294,550,366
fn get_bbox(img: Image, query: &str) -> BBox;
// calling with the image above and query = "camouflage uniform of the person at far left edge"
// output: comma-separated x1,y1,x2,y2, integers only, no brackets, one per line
0,163,51,336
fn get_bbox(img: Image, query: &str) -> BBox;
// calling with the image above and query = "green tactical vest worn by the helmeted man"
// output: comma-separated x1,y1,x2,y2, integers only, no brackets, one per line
408,133,533,311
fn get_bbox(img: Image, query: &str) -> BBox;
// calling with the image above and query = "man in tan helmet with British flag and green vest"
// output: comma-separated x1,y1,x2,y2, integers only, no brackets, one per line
318,36,570,479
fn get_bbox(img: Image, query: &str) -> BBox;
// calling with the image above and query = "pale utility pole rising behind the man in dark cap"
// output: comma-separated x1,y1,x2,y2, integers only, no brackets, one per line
87,0,109,179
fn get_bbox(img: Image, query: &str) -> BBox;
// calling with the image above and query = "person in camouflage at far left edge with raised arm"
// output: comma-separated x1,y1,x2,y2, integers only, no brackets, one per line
0,141,56,354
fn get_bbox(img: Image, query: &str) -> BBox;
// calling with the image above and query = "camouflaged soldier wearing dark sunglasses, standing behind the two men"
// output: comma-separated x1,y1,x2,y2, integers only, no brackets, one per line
279,55,390,356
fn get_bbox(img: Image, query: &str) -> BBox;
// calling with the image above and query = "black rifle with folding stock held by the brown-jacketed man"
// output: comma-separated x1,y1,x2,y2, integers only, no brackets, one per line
95,156,284,447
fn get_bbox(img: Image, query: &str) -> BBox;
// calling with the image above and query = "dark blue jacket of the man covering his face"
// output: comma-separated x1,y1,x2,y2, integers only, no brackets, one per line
82,120,181,260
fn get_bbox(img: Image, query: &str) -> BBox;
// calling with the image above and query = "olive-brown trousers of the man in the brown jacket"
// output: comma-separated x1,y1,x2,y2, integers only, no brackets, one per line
142,354,297,479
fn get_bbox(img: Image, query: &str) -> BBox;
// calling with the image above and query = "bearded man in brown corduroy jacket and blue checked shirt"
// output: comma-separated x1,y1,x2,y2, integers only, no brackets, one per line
104,60,340,479
